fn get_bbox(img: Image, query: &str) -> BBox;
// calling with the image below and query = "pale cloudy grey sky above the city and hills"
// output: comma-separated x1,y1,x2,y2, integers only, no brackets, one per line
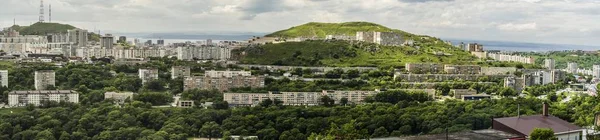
0,0,600,45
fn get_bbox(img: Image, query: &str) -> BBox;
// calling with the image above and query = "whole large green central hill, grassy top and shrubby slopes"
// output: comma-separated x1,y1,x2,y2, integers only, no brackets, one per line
232,22,477,67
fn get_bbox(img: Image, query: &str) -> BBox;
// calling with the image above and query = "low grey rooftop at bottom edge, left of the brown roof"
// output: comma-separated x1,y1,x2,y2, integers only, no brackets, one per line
380,129,519,140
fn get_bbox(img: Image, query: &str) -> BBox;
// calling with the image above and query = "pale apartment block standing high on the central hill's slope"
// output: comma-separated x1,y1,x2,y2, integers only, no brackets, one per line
356,32,405,46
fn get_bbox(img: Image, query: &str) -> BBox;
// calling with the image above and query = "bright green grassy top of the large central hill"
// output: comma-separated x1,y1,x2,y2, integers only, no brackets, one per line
266,22,414,38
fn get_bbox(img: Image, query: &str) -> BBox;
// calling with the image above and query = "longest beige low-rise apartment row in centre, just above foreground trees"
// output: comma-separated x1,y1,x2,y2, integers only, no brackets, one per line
223,90,379,106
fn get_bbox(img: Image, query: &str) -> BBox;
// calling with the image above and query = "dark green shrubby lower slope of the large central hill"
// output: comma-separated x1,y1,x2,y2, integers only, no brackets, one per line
237,40,476,67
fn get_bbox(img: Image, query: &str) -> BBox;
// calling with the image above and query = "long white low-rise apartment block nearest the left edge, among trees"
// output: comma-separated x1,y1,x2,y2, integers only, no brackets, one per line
8,90,79,107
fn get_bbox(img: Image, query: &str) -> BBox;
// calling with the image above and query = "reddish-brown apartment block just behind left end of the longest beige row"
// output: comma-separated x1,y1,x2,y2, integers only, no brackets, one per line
183,76,265,91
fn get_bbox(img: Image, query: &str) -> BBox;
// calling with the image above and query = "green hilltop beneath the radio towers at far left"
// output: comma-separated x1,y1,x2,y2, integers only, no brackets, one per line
10,22,75,35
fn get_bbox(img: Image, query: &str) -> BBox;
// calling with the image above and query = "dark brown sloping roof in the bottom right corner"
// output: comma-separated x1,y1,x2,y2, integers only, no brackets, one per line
494,115,582,135
